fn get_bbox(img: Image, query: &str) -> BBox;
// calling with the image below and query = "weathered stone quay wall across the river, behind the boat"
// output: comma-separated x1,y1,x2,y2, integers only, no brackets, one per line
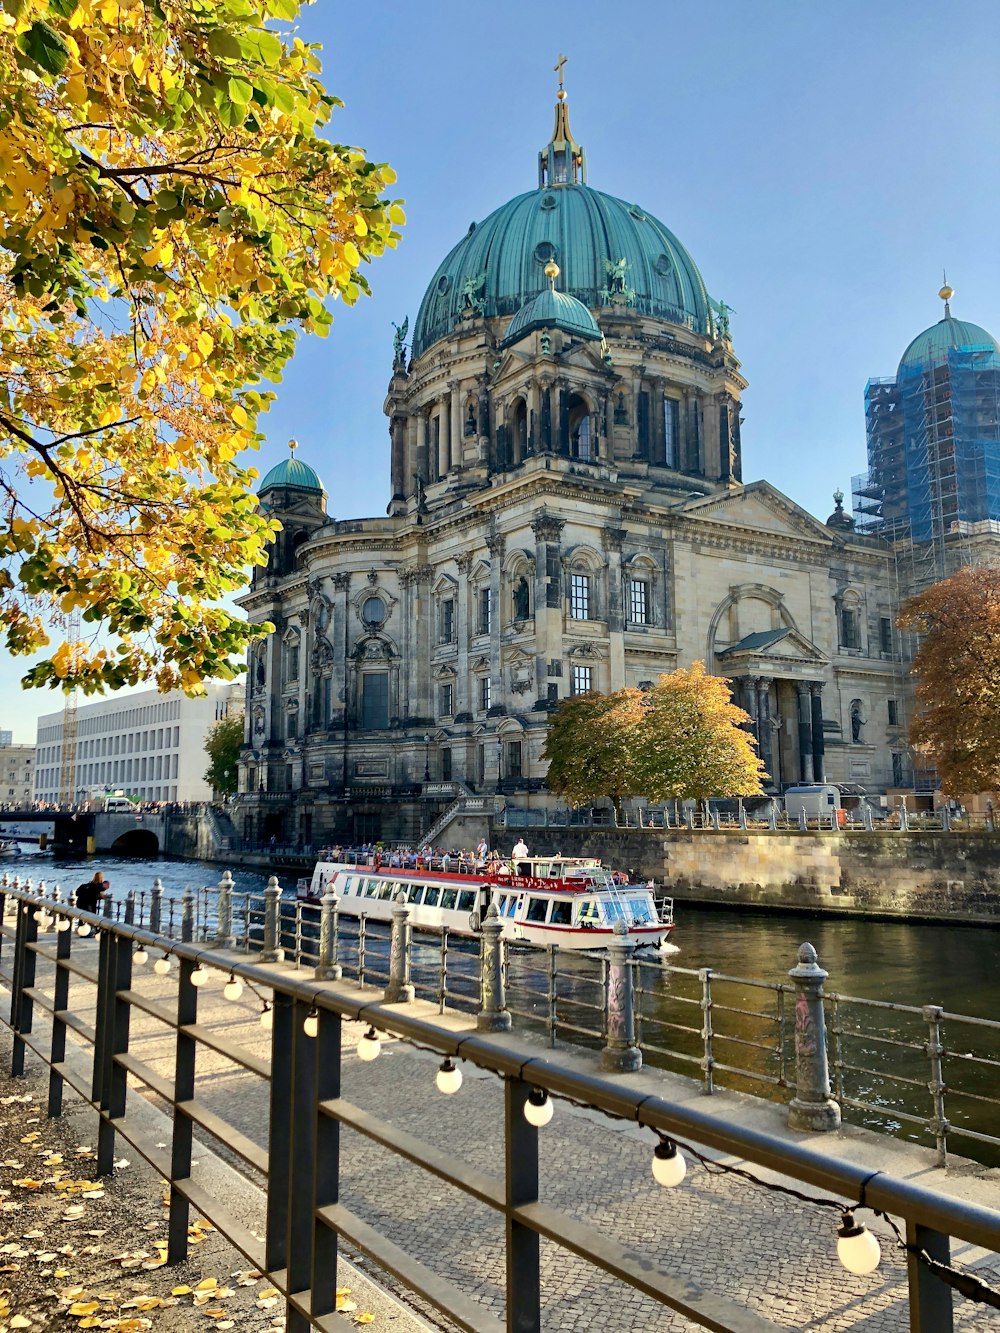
491,828,1000,926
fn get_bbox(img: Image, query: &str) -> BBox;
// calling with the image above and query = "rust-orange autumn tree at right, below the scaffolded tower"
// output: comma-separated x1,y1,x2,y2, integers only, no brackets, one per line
897,565,1000,796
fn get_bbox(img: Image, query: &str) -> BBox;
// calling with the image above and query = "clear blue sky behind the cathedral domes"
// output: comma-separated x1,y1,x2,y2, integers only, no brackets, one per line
0,0,1000,741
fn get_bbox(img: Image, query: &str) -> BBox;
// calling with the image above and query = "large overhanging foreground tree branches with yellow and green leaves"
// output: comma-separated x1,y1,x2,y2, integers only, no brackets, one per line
0,0,404,692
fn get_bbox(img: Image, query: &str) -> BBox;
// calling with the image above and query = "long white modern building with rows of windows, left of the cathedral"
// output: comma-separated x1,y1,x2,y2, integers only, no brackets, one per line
35,682,244,801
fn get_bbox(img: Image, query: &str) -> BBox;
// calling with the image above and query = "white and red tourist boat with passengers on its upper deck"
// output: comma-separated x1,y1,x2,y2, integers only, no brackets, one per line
299,856,673,949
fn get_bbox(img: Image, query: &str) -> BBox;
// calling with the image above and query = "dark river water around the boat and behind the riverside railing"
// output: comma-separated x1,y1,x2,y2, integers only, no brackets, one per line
3,850,1000,1164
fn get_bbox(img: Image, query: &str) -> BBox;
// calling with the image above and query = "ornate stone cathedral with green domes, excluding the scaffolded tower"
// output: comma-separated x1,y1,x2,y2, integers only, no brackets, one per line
240,87,905,844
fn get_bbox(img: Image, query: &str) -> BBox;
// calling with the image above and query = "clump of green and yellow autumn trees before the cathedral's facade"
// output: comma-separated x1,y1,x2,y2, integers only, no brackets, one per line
543,663,764,810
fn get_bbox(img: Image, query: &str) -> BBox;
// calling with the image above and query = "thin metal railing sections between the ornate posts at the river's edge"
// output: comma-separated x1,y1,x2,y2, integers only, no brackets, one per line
0,872,1000,1165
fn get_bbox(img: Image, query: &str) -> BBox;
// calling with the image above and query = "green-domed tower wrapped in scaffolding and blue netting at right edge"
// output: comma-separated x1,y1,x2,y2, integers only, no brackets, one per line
853,285,1000,593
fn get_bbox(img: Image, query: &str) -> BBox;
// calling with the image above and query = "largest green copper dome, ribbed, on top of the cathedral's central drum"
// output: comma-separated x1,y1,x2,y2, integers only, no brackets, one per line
413,183,712,356
